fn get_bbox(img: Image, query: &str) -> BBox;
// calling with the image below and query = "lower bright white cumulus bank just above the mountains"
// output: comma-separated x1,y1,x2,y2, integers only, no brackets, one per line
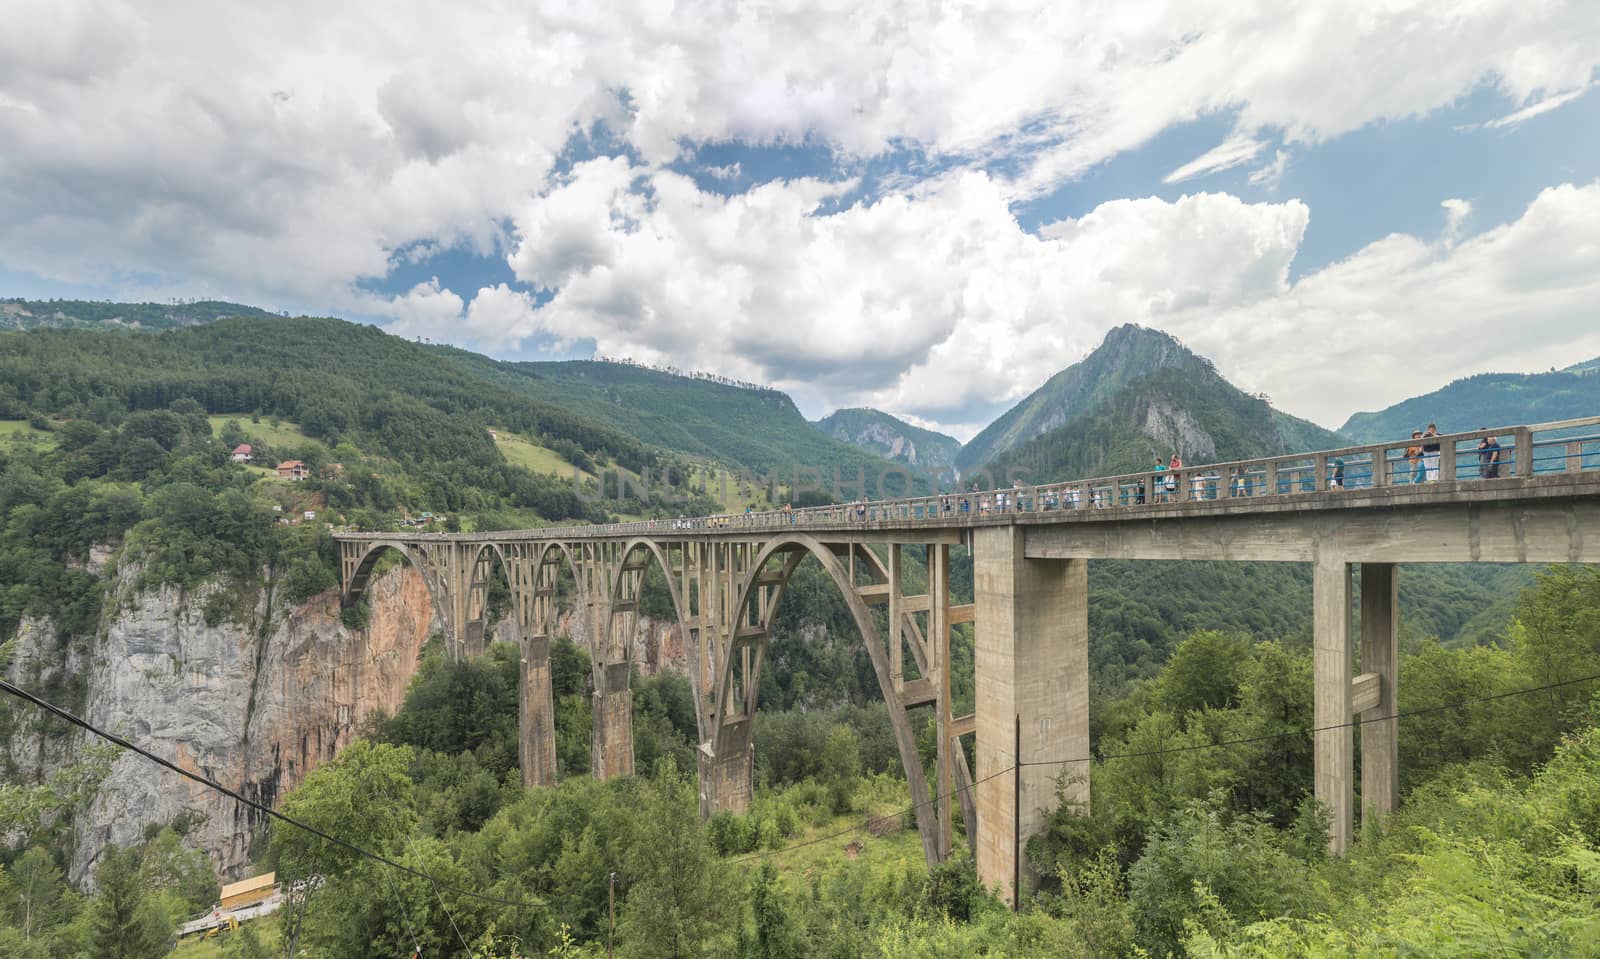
390,174,1600,439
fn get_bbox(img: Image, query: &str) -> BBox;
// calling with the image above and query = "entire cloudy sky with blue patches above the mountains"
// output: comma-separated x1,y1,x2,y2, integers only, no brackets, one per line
0,0,1600,439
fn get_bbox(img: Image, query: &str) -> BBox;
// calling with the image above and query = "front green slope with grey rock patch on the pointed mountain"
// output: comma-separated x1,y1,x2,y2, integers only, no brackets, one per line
987,341,1346,482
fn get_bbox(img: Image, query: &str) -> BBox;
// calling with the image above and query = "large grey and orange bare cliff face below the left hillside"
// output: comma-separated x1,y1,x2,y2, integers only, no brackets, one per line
72,567,432,877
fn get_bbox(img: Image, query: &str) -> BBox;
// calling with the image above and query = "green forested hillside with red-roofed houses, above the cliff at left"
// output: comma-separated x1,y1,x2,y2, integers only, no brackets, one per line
0,317,732,653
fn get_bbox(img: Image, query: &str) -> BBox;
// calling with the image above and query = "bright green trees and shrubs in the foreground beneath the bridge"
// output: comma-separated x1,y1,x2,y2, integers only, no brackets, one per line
0,568,1600,959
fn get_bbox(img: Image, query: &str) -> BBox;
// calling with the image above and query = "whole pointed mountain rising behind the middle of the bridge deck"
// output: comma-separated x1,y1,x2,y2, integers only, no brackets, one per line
963,327,1346,482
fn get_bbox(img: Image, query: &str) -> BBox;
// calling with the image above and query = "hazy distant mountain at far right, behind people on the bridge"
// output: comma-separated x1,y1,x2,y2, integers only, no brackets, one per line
1341,369,1600,443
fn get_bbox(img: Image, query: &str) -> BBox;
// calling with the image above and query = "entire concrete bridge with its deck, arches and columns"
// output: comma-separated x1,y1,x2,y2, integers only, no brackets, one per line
336,416,1600,895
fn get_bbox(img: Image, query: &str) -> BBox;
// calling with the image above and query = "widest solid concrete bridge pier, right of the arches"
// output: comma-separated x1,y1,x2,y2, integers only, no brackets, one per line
973,527,1090,900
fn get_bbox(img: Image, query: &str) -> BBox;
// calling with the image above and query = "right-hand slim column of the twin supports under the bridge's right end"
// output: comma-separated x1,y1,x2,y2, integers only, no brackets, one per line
1362,564,1400,823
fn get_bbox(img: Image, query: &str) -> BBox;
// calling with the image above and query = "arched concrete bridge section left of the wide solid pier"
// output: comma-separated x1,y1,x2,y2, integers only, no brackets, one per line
339,530,974,861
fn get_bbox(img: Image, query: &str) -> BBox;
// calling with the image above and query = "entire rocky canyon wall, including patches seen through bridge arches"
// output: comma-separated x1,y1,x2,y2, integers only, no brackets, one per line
0,565,686,882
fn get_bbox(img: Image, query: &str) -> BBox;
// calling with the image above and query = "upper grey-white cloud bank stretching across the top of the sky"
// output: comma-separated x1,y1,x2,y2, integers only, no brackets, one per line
0,0,1600,309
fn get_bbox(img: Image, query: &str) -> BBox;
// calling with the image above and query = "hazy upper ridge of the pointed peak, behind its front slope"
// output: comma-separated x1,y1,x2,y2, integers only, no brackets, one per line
955,323,1211,471
